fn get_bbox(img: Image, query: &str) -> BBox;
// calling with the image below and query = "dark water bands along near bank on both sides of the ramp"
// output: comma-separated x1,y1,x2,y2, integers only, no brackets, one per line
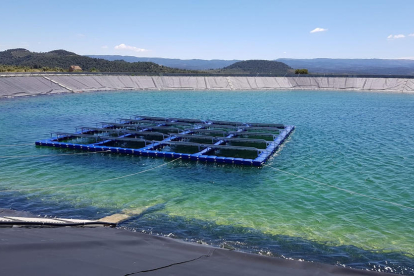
0,183,414,275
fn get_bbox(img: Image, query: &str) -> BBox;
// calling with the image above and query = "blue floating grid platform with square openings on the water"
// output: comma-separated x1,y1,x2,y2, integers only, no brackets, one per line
36,115,295,167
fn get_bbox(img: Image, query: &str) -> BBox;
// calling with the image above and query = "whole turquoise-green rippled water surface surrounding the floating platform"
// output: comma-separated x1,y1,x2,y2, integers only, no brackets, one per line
0,91,414,274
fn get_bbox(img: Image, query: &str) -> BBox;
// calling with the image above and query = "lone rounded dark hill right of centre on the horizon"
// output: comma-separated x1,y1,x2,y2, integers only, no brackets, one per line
220,60,293,75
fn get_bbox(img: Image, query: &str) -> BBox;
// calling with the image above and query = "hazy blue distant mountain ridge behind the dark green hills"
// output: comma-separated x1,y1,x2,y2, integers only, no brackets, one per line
90,55,414,75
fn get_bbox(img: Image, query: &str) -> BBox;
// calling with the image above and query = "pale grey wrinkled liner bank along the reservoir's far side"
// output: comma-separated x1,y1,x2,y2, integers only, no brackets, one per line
0,74,414,97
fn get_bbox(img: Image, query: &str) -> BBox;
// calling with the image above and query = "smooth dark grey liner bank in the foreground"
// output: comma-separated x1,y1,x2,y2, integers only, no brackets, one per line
0,227,382,276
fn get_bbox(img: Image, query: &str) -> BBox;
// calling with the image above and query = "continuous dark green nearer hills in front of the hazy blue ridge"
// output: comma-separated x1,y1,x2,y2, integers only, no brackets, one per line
0,49,294,76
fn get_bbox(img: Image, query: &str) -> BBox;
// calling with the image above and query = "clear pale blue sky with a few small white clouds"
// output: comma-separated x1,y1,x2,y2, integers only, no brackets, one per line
0,0,414,59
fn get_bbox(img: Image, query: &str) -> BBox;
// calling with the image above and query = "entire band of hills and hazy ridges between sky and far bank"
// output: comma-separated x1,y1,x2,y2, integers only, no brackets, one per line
0,48,414,76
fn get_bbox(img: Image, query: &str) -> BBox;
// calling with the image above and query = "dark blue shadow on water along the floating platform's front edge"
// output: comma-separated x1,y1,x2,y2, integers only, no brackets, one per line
25,146,263,188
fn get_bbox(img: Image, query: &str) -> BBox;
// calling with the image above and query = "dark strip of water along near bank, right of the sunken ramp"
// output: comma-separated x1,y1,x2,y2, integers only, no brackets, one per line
121,212,414,275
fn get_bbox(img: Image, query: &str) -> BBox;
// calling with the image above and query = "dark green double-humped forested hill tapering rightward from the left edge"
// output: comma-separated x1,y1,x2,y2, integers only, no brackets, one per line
0,49,197,73
